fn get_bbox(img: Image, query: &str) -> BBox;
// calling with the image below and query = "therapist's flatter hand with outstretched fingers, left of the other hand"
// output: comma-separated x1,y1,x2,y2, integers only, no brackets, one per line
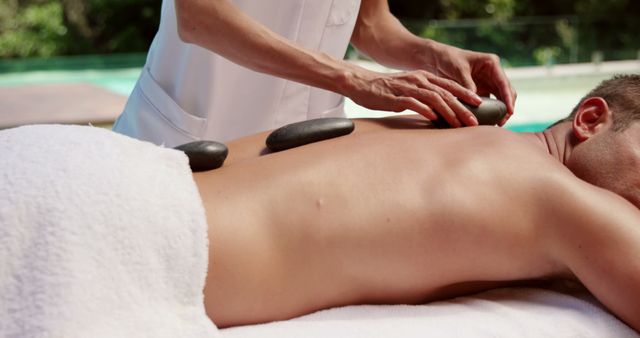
340,66,482,127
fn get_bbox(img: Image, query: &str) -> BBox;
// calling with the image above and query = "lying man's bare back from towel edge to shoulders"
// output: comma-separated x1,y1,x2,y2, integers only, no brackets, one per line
194,115,637,326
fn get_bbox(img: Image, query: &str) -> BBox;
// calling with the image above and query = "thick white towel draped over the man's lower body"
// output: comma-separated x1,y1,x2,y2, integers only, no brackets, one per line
0,125,217,337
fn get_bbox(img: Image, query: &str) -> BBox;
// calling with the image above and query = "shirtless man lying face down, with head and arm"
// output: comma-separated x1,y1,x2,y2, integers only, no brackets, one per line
194,75,640,330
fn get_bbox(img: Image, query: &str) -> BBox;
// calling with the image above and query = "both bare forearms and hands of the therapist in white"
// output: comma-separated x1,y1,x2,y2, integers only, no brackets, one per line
175,0,516,127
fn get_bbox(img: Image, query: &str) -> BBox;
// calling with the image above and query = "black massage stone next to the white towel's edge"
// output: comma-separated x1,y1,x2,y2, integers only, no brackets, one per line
175,141,229,172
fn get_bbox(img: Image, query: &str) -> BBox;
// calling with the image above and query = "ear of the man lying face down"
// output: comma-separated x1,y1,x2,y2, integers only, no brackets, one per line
573,97,613,141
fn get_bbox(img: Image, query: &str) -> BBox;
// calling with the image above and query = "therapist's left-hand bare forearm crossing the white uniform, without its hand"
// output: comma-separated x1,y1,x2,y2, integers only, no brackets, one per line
175,0,352,92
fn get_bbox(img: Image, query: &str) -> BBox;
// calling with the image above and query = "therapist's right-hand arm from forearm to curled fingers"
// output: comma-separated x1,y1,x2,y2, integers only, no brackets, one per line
351,0,516,125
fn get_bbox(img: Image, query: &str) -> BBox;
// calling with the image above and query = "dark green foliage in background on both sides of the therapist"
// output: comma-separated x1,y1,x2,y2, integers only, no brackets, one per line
0,0,640,66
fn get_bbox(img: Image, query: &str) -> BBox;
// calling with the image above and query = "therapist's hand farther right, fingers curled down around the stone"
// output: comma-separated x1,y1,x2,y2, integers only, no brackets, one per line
425,41,517,126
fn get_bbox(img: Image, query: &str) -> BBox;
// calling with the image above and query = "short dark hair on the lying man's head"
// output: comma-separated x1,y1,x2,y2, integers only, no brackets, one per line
552,74,640,131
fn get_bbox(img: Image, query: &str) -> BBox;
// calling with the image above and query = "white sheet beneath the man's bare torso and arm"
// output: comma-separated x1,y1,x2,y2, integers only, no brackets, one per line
220,287,640,338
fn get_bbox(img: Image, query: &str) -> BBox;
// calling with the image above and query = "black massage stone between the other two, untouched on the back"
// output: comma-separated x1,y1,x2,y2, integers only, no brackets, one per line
266,117,355,151
